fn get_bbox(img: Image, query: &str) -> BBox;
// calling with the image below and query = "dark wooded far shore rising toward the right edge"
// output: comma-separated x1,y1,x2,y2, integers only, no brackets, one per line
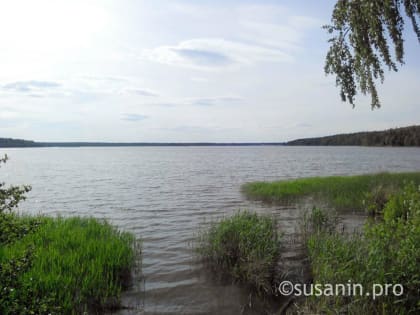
286,126,420,146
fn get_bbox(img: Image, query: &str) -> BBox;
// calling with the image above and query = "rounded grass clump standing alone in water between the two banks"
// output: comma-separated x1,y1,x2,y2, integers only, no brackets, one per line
198,211,280,293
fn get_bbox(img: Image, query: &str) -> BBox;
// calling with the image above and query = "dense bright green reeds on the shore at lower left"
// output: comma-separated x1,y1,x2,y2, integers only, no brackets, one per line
0,213,136,314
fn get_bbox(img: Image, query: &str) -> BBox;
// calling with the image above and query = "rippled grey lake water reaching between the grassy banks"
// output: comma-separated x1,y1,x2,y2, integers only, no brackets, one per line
0,146,420,314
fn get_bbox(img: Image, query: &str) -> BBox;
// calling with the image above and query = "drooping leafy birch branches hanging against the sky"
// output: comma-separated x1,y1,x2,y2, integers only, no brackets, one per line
324,0,420,108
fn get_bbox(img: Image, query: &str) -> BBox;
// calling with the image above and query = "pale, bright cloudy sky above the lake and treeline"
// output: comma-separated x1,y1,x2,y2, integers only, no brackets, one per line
0,0,420,142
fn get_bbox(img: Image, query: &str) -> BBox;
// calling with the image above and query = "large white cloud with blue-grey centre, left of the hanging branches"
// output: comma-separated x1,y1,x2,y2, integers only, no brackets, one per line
141,4,322,70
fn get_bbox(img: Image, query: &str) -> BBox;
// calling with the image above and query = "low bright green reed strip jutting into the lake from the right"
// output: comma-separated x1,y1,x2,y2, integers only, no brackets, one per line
242,172,420,210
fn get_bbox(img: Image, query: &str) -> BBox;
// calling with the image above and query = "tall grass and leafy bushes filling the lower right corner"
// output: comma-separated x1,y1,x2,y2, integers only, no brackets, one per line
306,183,420,314
